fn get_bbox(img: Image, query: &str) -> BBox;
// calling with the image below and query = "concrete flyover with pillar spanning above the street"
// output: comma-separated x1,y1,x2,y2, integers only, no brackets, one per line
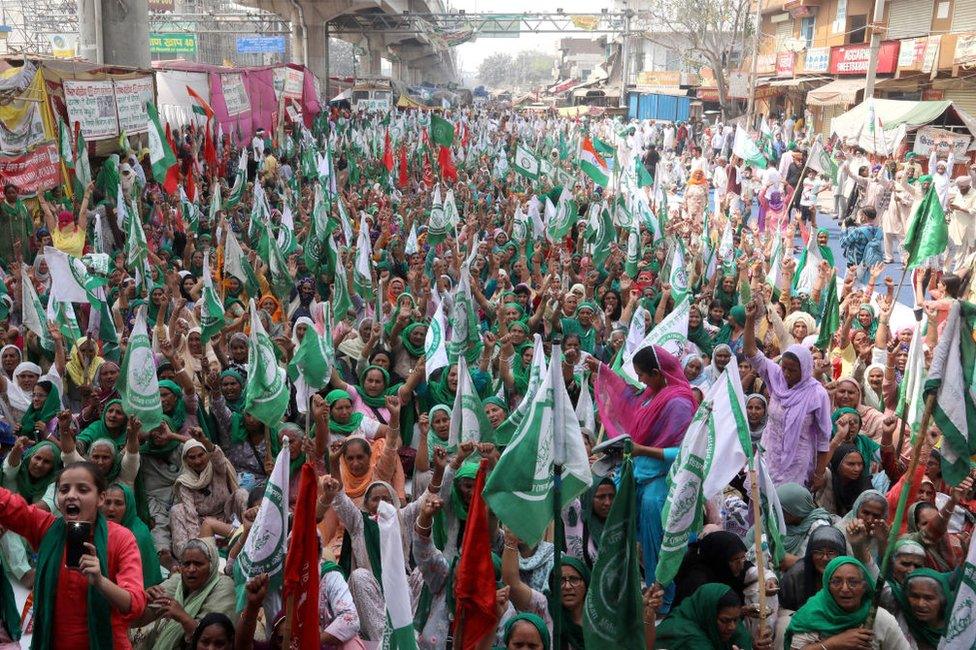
233,0,458,92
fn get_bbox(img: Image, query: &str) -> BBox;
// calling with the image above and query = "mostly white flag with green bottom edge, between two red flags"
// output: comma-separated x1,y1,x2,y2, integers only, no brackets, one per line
376,501,417,650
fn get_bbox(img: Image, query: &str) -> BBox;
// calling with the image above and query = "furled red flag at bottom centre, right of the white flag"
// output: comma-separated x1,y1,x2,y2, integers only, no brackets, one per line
454,459,498,650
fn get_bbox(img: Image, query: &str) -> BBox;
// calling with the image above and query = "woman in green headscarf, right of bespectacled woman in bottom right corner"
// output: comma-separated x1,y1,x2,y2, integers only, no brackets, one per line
890,568,952,650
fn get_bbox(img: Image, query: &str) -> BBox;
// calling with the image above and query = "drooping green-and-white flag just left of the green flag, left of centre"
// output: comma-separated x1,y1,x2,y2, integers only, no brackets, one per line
244,298,290,427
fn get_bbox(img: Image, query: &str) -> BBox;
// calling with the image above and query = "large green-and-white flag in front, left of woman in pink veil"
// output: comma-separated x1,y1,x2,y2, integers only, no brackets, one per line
484,345,591,546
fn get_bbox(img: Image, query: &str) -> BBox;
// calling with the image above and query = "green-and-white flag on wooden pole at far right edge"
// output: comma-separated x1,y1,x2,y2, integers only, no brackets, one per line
925,300,976,485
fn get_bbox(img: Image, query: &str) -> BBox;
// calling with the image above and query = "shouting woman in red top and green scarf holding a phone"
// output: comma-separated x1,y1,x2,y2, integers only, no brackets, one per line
0,462,146,650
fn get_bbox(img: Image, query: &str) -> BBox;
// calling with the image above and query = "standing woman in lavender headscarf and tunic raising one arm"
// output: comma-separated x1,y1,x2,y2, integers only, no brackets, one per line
744,300,831,491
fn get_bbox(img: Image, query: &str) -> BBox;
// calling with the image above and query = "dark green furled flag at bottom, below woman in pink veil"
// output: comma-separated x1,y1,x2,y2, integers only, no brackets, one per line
583,454,645,650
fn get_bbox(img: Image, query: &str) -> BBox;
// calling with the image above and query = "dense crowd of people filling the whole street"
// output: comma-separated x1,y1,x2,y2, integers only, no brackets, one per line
0,97,976,650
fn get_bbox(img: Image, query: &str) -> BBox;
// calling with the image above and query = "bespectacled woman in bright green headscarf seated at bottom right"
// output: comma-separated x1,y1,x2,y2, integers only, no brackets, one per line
783,555,909,650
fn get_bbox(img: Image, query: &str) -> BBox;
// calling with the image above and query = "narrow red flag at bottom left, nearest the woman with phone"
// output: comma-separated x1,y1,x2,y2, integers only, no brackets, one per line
281,463,320,648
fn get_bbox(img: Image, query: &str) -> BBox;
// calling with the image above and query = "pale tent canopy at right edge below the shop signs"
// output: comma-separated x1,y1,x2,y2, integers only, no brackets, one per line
828,98,976,145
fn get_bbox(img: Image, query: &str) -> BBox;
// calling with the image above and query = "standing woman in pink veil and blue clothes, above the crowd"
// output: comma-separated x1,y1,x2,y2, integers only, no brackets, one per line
593,345,698,611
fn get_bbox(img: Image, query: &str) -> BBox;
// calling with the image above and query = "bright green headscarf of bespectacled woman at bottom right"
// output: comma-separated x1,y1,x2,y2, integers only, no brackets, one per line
783,555,874,648
